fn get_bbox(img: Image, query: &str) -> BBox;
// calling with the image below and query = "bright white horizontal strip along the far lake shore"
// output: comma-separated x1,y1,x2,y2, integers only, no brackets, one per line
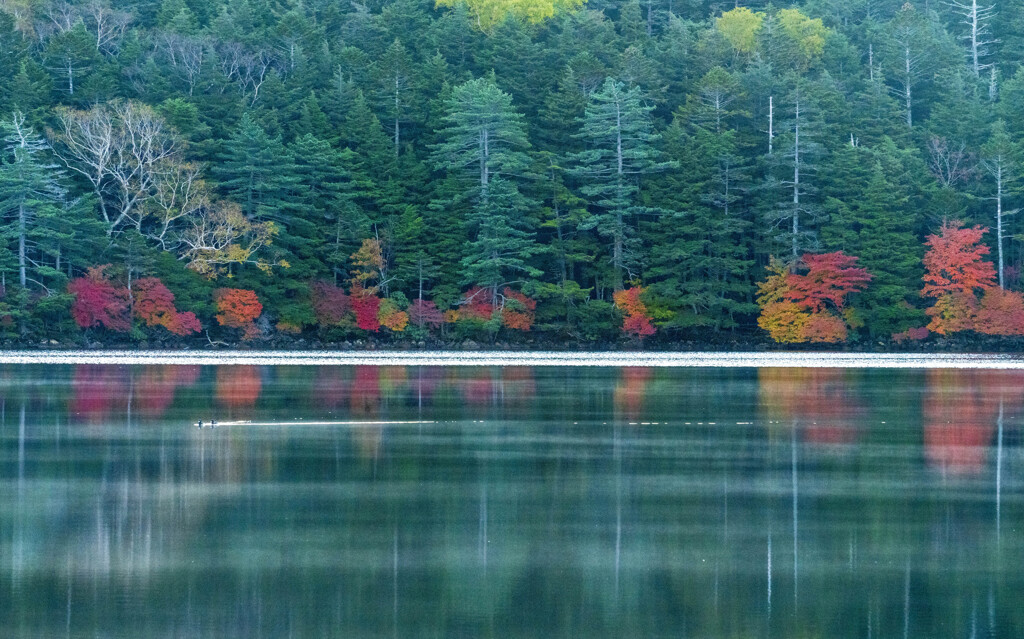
0,350,1024,370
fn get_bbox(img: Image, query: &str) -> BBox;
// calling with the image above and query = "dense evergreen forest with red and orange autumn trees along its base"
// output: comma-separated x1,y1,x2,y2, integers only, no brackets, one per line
0,0,1024,347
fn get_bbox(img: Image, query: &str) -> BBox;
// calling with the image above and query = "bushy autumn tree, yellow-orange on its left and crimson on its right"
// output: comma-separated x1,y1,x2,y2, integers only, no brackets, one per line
758,251,871,343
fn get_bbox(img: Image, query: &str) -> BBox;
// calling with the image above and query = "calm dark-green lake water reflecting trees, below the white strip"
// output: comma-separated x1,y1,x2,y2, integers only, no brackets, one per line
0,366,1024,639
